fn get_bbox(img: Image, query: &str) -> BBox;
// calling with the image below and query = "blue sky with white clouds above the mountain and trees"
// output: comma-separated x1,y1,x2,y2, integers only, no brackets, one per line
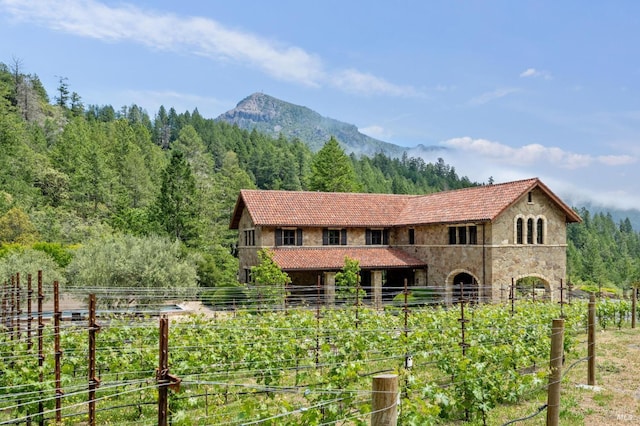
0,0,640,208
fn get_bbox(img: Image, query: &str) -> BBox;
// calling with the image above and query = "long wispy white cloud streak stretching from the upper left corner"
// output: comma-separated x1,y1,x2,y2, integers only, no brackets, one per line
0,0,420,97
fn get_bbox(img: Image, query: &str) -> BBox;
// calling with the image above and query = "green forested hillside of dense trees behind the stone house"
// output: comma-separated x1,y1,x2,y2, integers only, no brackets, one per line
0,61,640,294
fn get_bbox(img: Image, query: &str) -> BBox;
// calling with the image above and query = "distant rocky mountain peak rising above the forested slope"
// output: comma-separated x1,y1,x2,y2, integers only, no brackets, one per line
216,93,443,157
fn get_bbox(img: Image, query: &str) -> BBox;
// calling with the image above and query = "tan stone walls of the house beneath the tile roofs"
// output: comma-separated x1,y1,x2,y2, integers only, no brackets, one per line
231,180,579,304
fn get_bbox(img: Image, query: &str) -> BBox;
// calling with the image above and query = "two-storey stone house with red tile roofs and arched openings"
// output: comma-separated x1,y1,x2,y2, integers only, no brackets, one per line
230,178,581,304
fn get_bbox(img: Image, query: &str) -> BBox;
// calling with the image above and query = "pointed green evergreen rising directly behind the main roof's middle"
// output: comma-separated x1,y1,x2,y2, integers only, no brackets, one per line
309,137,360,192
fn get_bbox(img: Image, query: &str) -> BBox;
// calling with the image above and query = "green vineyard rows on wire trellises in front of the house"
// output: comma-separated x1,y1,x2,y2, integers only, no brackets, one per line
0,274,632,425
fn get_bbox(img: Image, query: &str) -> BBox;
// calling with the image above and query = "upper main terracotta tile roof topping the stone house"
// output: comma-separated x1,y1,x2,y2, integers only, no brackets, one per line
230,178,580,229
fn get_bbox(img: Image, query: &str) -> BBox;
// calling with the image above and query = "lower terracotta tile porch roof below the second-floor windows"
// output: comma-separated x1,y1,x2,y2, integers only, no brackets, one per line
273,247,427,271
